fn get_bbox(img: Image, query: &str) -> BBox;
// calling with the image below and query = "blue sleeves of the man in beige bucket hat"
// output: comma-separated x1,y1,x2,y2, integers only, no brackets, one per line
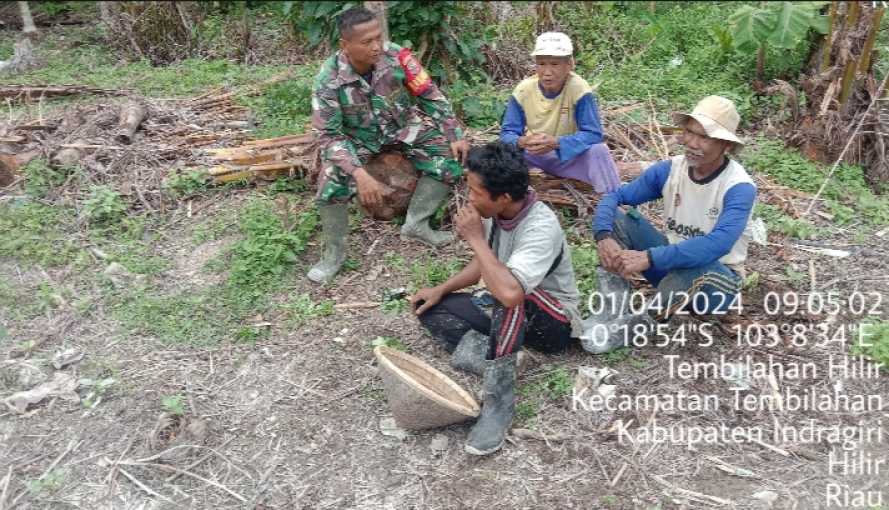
593,160,756,271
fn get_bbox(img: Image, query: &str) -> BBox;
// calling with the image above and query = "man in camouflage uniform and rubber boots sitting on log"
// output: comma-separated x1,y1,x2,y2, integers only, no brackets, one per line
308,8,469,283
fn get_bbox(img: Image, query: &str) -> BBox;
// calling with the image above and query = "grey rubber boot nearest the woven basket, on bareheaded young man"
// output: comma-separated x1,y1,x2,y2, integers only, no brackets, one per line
465,354,516,455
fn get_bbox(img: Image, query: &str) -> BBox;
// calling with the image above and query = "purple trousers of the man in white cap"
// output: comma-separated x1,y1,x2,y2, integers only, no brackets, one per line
525,143,620,193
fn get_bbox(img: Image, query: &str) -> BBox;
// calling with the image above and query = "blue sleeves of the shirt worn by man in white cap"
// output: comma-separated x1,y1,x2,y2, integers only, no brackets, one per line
500,90,604,161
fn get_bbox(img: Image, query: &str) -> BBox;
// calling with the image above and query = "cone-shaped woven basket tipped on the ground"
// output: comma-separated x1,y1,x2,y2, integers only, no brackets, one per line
374,345,479,430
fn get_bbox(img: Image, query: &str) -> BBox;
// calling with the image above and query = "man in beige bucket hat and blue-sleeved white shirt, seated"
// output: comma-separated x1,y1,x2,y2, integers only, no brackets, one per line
582,96,756,352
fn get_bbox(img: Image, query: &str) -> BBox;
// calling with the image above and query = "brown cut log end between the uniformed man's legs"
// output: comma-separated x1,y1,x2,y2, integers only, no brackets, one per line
359,151,417,221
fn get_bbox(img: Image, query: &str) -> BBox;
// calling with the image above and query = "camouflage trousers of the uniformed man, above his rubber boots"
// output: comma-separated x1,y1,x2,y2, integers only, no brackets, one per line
316,125,463,205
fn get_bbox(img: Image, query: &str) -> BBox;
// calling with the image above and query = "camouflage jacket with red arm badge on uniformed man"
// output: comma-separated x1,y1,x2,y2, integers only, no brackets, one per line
312,42,463,174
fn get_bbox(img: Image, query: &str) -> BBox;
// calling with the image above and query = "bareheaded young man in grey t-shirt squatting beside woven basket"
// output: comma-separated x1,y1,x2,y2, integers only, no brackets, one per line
411,143,580,455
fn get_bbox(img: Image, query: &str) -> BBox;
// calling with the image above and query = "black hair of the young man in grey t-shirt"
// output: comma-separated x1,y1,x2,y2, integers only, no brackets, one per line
466,142,530,201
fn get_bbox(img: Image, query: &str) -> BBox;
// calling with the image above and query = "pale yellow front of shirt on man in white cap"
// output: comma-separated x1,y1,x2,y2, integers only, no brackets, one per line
512,72,593,137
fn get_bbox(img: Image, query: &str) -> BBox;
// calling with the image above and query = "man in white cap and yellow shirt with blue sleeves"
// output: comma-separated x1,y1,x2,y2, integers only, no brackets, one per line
500,32,620,193
